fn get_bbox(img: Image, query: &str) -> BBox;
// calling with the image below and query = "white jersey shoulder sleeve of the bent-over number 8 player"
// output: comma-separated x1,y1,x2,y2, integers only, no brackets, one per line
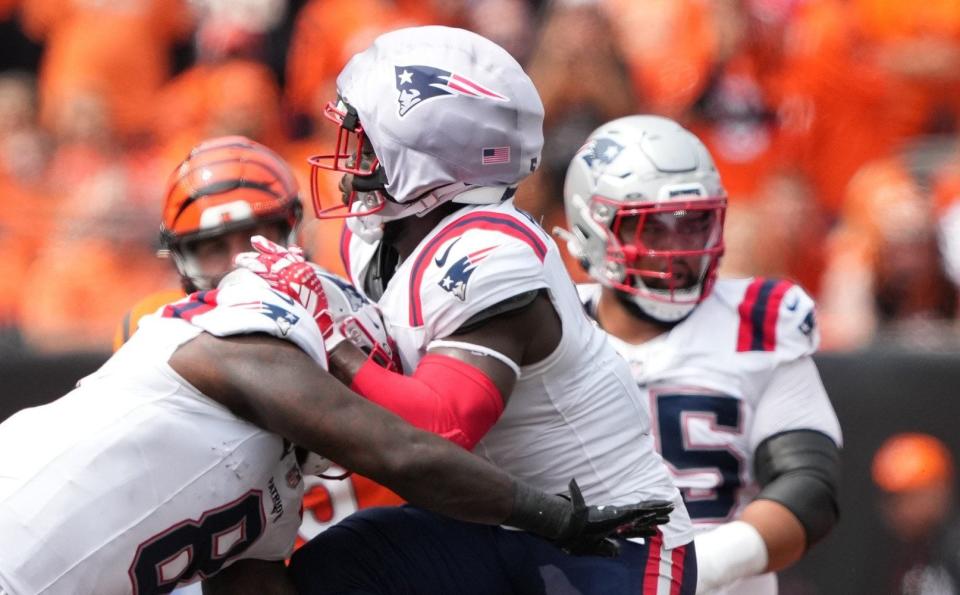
161,269,327,367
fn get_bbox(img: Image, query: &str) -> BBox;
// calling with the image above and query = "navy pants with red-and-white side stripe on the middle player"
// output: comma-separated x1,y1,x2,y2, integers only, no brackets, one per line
290,506,697,595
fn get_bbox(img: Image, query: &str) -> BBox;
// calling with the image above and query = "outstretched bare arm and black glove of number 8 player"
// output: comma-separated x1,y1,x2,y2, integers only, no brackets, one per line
169,333,671,553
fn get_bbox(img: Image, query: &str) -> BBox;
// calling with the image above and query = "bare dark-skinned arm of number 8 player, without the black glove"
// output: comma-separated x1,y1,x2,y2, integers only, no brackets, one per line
169,333,515,524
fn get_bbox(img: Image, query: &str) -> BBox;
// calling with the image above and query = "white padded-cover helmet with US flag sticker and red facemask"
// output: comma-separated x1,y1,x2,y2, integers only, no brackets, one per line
310,26,543,240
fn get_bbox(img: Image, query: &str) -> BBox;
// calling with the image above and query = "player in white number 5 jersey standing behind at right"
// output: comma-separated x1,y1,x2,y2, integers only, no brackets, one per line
560,116,841,595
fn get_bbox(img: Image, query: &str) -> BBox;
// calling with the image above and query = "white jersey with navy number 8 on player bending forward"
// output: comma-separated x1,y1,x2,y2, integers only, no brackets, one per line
0,270,326,595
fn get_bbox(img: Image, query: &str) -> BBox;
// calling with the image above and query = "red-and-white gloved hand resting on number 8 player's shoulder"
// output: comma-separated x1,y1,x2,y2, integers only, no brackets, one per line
234,236,344,353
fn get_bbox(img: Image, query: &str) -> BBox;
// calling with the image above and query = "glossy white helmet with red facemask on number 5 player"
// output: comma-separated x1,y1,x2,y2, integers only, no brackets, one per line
563,116,727,322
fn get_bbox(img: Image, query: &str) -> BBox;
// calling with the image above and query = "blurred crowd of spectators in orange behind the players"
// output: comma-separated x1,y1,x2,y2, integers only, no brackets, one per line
0,0,960,353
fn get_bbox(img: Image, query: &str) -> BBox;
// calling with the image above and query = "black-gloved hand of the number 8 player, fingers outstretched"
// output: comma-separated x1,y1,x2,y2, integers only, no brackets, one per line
556,480,673,557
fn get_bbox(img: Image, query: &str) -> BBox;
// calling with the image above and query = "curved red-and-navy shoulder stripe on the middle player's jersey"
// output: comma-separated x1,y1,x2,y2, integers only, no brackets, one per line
409,212,547,327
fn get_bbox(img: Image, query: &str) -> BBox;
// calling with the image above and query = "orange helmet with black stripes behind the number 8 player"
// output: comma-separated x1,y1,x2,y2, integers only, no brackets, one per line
160,136,303,251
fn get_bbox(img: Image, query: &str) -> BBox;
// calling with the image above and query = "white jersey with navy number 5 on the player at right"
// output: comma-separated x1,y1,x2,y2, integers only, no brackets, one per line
578,278,841,594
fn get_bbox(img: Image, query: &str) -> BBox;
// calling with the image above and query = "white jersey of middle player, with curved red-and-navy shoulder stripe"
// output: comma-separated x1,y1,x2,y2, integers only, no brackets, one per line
343,200,692,548
